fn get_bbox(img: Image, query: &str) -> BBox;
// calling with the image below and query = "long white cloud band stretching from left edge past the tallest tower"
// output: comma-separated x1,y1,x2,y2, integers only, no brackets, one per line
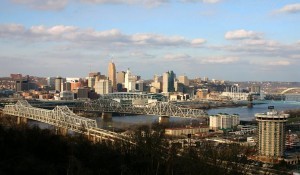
0,24,205,47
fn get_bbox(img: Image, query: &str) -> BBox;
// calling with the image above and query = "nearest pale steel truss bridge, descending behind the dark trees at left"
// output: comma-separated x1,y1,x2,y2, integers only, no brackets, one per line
2,100,132,143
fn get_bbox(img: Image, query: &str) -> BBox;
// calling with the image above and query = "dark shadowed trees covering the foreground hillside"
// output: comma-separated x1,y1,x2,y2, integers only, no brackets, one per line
0,117,255,175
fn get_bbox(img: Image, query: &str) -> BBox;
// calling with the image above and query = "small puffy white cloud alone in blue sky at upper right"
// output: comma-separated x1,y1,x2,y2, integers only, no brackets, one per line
225,29,260,40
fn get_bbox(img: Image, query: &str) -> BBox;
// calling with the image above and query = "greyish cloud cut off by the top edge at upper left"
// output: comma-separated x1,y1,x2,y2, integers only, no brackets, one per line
11,0,68,10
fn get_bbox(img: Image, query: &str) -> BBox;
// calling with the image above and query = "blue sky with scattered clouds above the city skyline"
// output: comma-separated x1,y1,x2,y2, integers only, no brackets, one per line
0,0,300,81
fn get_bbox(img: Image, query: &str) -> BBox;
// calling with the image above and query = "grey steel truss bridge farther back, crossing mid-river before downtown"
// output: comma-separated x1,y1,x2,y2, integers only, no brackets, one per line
76,98,207,118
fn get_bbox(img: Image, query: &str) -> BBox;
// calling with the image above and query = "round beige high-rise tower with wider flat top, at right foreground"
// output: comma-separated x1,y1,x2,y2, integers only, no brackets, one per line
255,106,289,160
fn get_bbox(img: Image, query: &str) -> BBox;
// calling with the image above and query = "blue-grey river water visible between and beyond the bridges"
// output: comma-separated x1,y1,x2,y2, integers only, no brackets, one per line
30,101,300,130
